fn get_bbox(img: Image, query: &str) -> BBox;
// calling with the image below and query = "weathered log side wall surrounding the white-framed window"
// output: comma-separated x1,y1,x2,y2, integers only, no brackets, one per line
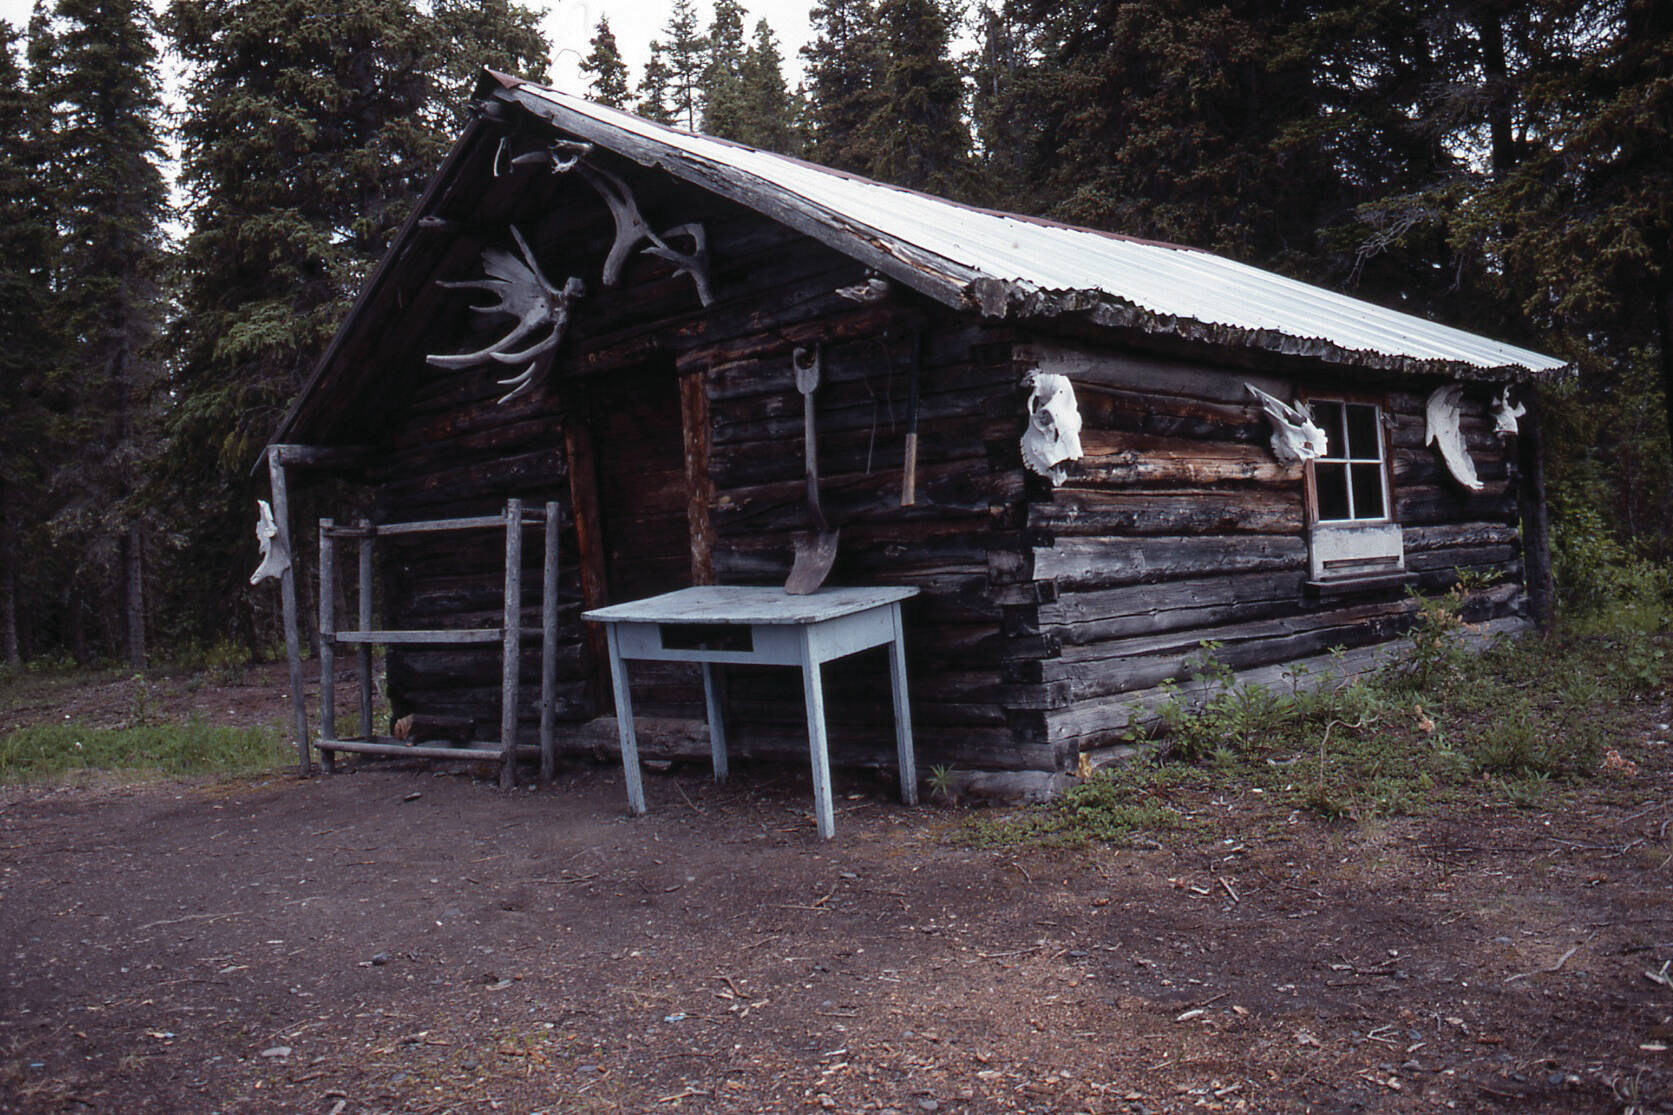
1007,343,1526,767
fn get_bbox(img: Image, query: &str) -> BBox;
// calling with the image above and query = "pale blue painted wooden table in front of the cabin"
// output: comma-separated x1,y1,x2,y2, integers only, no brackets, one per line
582,584,918,840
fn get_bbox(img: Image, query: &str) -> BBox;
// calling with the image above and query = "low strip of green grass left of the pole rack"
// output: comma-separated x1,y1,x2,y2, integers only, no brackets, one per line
0,720,289,782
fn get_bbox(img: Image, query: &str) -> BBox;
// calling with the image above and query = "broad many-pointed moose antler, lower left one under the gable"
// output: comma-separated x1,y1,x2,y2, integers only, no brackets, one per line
425,224,587,403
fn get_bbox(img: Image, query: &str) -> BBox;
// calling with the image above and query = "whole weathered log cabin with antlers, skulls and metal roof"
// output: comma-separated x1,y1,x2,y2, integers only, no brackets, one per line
257,72,1566,772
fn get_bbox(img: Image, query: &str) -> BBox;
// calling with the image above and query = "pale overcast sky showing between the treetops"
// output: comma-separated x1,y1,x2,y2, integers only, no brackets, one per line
0,0,813,94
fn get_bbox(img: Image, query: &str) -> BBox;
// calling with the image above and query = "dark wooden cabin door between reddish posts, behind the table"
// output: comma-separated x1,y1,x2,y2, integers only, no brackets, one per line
565,363,708,717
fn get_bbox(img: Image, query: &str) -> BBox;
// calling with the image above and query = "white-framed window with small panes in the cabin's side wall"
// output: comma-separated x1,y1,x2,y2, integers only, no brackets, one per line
1307,397,1405,584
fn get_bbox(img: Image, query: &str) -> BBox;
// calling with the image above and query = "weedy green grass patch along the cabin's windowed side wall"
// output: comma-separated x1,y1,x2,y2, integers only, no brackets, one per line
965,616,1673,845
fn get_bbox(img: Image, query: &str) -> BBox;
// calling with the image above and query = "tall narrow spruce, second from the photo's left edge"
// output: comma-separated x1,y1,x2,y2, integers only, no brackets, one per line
38,0,167,668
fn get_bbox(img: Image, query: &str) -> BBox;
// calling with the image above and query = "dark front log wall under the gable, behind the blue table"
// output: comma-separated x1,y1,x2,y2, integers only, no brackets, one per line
358,152,1023,767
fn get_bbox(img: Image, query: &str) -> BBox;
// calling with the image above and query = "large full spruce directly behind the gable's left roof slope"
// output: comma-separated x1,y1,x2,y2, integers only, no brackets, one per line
161,0,544,635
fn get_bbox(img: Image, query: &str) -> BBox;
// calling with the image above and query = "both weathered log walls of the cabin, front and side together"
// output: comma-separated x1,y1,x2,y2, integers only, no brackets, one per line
322,130,1524,770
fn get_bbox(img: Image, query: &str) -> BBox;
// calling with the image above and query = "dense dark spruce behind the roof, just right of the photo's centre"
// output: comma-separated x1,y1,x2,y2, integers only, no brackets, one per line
855,0,970,198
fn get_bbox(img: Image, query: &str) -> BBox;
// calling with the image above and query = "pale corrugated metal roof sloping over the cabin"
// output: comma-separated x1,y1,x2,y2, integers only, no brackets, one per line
502,79,1568,377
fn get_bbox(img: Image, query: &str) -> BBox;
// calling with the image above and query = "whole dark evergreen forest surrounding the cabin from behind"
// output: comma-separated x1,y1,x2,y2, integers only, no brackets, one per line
0,0,1673,670
